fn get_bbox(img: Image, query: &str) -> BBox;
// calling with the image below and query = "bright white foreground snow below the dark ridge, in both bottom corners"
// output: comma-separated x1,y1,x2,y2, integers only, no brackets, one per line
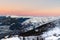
1,26,60,40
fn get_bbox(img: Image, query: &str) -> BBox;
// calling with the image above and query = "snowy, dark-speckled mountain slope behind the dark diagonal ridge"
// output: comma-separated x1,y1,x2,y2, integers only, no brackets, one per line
22,17,60,32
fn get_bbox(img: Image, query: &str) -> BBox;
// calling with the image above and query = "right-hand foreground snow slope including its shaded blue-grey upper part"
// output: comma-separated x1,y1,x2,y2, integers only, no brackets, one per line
41,19,60,40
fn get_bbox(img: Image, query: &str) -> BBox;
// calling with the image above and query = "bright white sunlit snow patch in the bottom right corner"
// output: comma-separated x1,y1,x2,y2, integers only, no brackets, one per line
42,26,60,40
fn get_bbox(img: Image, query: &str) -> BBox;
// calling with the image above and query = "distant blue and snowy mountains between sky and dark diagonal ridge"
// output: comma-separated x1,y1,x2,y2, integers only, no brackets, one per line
0,16,60,39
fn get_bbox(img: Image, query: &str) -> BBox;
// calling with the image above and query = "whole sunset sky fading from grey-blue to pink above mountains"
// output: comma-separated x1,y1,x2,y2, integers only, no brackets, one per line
0,0,60,16
